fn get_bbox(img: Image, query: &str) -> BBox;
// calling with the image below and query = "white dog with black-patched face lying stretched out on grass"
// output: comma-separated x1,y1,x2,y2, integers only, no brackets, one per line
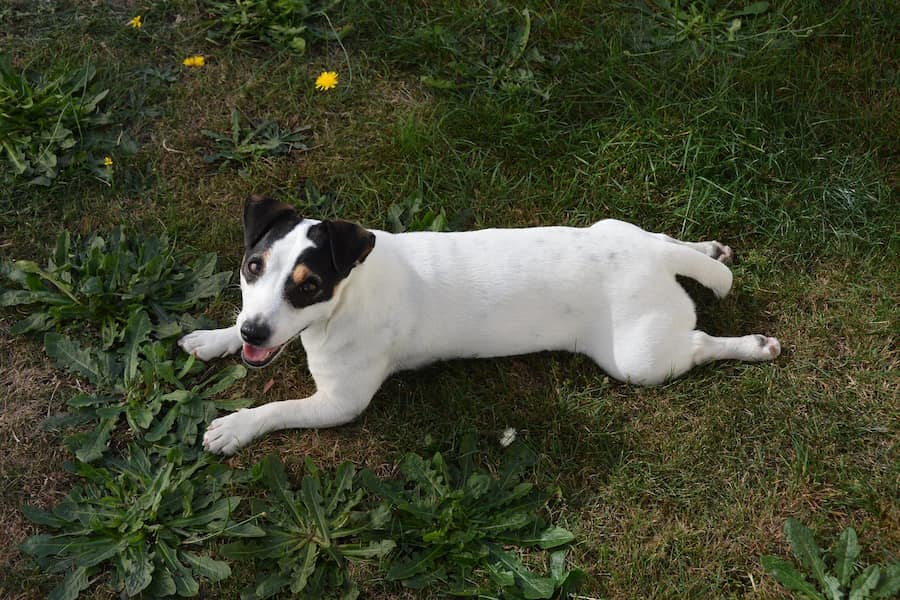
179,196,781,455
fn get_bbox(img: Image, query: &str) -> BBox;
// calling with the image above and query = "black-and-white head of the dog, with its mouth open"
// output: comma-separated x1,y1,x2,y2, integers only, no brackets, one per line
237,196,375,367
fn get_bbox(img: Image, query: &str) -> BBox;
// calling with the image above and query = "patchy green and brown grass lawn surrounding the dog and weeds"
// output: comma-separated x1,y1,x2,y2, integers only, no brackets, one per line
0,0,900,598
